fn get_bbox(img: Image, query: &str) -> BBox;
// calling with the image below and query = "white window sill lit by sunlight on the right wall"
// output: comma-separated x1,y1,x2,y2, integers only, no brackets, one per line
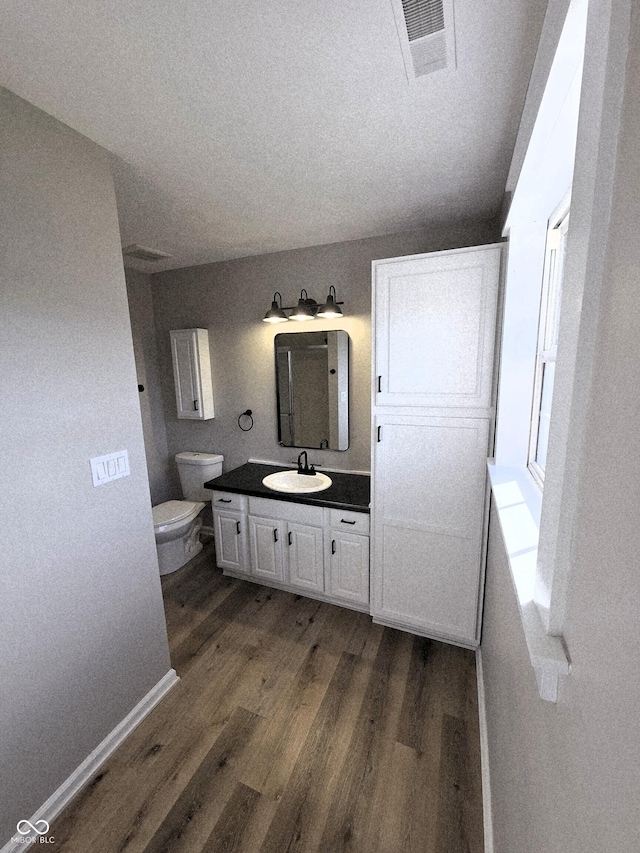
487,459,570,702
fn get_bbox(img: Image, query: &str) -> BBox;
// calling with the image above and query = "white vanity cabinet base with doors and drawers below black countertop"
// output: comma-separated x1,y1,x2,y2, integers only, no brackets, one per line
212,491,369,610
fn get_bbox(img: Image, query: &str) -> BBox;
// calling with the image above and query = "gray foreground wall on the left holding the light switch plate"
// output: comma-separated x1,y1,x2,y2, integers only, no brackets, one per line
0,90,170,845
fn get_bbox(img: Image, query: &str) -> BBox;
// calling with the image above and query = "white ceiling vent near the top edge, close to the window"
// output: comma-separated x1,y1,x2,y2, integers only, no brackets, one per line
391,0,456,83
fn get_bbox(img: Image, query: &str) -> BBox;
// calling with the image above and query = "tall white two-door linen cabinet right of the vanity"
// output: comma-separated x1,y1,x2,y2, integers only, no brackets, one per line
371,244,504,648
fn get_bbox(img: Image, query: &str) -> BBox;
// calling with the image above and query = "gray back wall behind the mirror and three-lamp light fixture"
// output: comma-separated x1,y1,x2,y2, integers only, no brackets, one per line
152,222,500,471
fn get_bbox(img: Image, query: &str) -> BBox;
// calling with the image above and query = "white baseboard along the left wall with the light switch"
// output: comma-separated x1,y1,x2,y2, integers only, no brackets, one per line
0,669,180,853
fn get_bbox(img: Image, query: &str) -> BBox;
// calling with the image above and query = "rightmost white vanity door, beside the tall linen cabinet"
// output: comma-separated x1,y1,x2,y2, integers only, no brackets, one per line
327,530,369,604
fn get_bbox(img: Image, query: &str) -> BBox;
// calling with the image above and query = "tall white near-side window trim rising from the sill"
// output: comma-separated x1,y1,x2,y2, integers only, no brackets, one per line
535,0,634,634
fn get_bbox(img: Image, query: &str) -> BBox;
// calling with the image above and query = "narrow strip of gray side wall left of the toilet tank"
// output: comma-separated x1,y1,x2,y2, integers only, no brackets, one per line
125,270,179,506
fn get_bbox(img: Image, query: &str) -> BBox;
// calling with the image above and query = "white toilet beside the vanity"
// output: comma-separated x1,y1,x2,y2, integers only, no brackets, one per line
152,451,224,575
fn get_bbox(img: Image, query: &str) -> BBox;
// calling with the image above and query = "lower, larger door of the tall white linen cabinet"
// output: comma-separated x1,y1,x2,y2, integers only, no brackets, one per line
371,415,489,645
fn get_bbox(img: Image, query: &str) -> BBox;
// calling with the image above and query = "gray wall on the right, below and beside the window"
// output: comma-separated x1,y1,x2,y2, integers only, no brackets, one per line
482,3,640,853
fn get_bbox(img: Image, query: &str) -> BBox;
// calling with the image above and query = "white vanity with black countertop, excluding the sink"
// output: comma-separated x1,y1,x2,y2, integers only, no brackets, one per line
205,462,370,612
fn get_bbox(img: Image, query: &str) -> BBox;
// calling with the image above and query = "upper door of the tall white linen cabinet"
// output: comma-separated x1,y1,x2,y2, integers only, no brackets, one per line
374,245,502,410
